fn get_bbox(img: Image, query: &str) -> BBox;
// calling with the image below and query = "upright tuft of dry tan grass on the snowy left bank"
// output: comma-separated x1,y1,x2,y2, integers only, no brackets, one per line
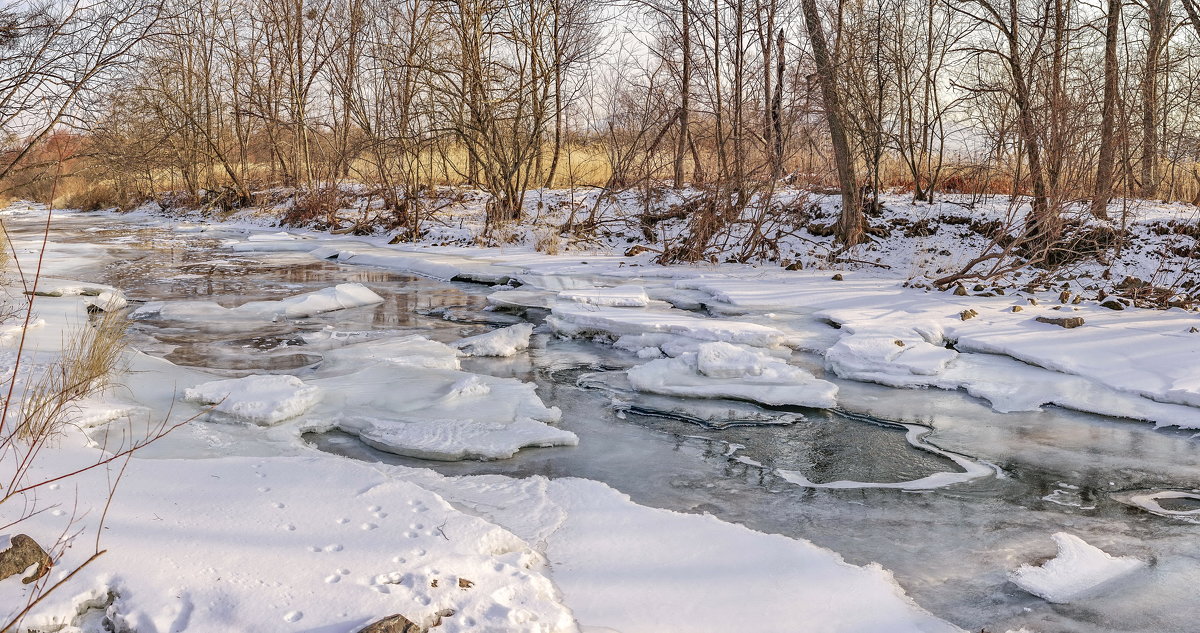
17,311,127,440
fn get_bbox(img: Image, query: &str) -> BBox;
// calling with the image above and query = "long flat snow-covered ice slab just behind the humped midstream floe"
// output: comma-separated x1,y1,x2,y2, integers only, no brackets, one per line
546,303,787,348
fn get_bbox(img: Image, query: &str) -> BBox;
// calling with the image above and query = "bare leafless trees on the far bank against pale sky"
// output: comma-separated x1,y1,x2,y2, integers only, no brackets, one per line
7,0,1200,245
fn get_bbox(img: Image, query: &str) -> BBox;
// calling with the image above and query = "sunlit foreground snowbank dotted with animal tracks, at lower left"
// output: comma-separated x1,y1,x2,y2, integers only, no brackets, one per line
8,456,578,633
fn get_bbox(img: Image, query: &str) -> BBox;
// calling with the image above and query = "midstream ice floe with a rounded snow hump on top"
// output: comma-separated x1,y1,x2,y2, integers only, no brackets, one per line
626,343,838,408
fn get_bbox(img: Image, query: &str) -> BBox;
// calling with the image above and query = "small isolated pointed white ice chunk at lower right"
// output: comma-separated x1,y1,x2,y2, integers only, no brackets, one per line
1008,532,1146,604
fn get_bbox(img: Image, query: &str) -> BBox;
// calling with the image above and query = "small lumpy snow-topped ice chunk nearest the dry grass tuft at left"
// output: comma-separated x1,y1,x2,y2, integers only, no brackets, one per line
184,375,320,426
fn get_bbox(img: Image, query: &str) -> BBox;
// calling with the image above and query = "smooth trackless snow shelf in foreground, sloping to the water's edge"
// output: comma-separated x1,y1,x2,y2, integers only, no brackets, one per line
408,476,961,633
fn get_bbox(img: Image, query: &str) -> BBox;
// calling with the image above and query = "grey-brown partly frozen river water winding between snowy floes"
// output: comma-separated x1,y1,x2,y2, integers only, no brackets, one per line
14,215,1200,633
